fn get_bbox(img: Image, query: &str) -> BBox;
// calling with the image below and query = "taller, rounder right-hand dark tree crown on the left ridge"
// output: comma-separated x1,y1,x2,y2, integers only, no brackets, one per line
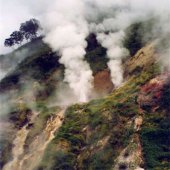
20,19,39,40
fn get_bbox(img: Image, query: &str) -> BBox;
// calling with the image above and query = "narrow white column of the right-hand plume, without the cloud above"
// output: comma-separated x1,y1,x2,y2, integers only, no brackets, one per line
97,31,128,87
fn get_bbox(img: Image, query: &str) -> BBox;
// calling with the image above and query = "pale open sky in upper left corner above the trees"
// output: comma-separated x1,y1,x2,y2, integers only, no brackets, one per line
0,0,38,54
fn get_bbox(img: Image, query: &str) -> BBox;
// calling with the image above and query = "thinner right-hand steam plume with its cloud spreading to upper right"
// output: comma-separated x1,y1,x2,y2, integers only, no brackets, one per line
86,0,170,86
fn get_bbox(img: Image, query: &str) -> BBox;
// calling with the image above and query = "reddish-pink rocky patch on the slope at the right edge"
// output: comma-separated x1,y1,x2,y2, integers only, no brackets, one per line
137,73,170,111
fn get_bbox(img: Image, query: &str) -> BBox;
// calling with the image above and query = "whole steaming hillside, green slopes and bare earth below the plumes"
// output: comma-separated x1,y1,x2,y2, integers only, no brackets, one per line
0,35,170,170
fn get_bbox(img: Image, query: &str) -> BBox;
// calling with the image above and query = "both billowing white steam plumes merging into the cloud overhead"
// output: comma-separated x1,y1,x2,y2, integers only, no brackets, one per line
0,0,170,101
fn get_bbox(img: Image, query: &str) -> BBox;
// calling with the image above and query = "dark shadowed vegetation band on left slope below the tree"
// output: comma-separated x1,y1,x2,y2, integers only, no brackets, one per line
0,42,63,92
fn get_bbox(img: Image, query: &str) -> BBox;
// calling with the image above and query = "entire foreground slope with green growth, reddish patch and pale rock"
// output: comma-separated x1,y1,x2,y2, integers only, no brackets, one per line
38,41,170,170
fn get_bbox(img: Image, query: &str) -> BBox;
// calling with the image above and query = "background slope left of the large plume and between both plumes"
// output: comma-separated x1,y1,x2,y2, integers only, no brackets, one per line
0,35,113,167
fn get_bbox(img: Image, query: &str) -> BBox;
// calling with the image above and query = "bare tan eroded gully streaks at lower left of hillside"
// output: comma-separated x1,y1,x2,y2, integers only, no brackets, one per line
3,110,65,170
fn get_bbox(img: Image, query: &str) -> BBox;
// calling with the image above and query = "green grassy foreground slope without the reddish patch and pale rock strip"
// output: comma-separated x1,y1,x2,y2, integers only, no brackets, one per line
38,42,169,170
